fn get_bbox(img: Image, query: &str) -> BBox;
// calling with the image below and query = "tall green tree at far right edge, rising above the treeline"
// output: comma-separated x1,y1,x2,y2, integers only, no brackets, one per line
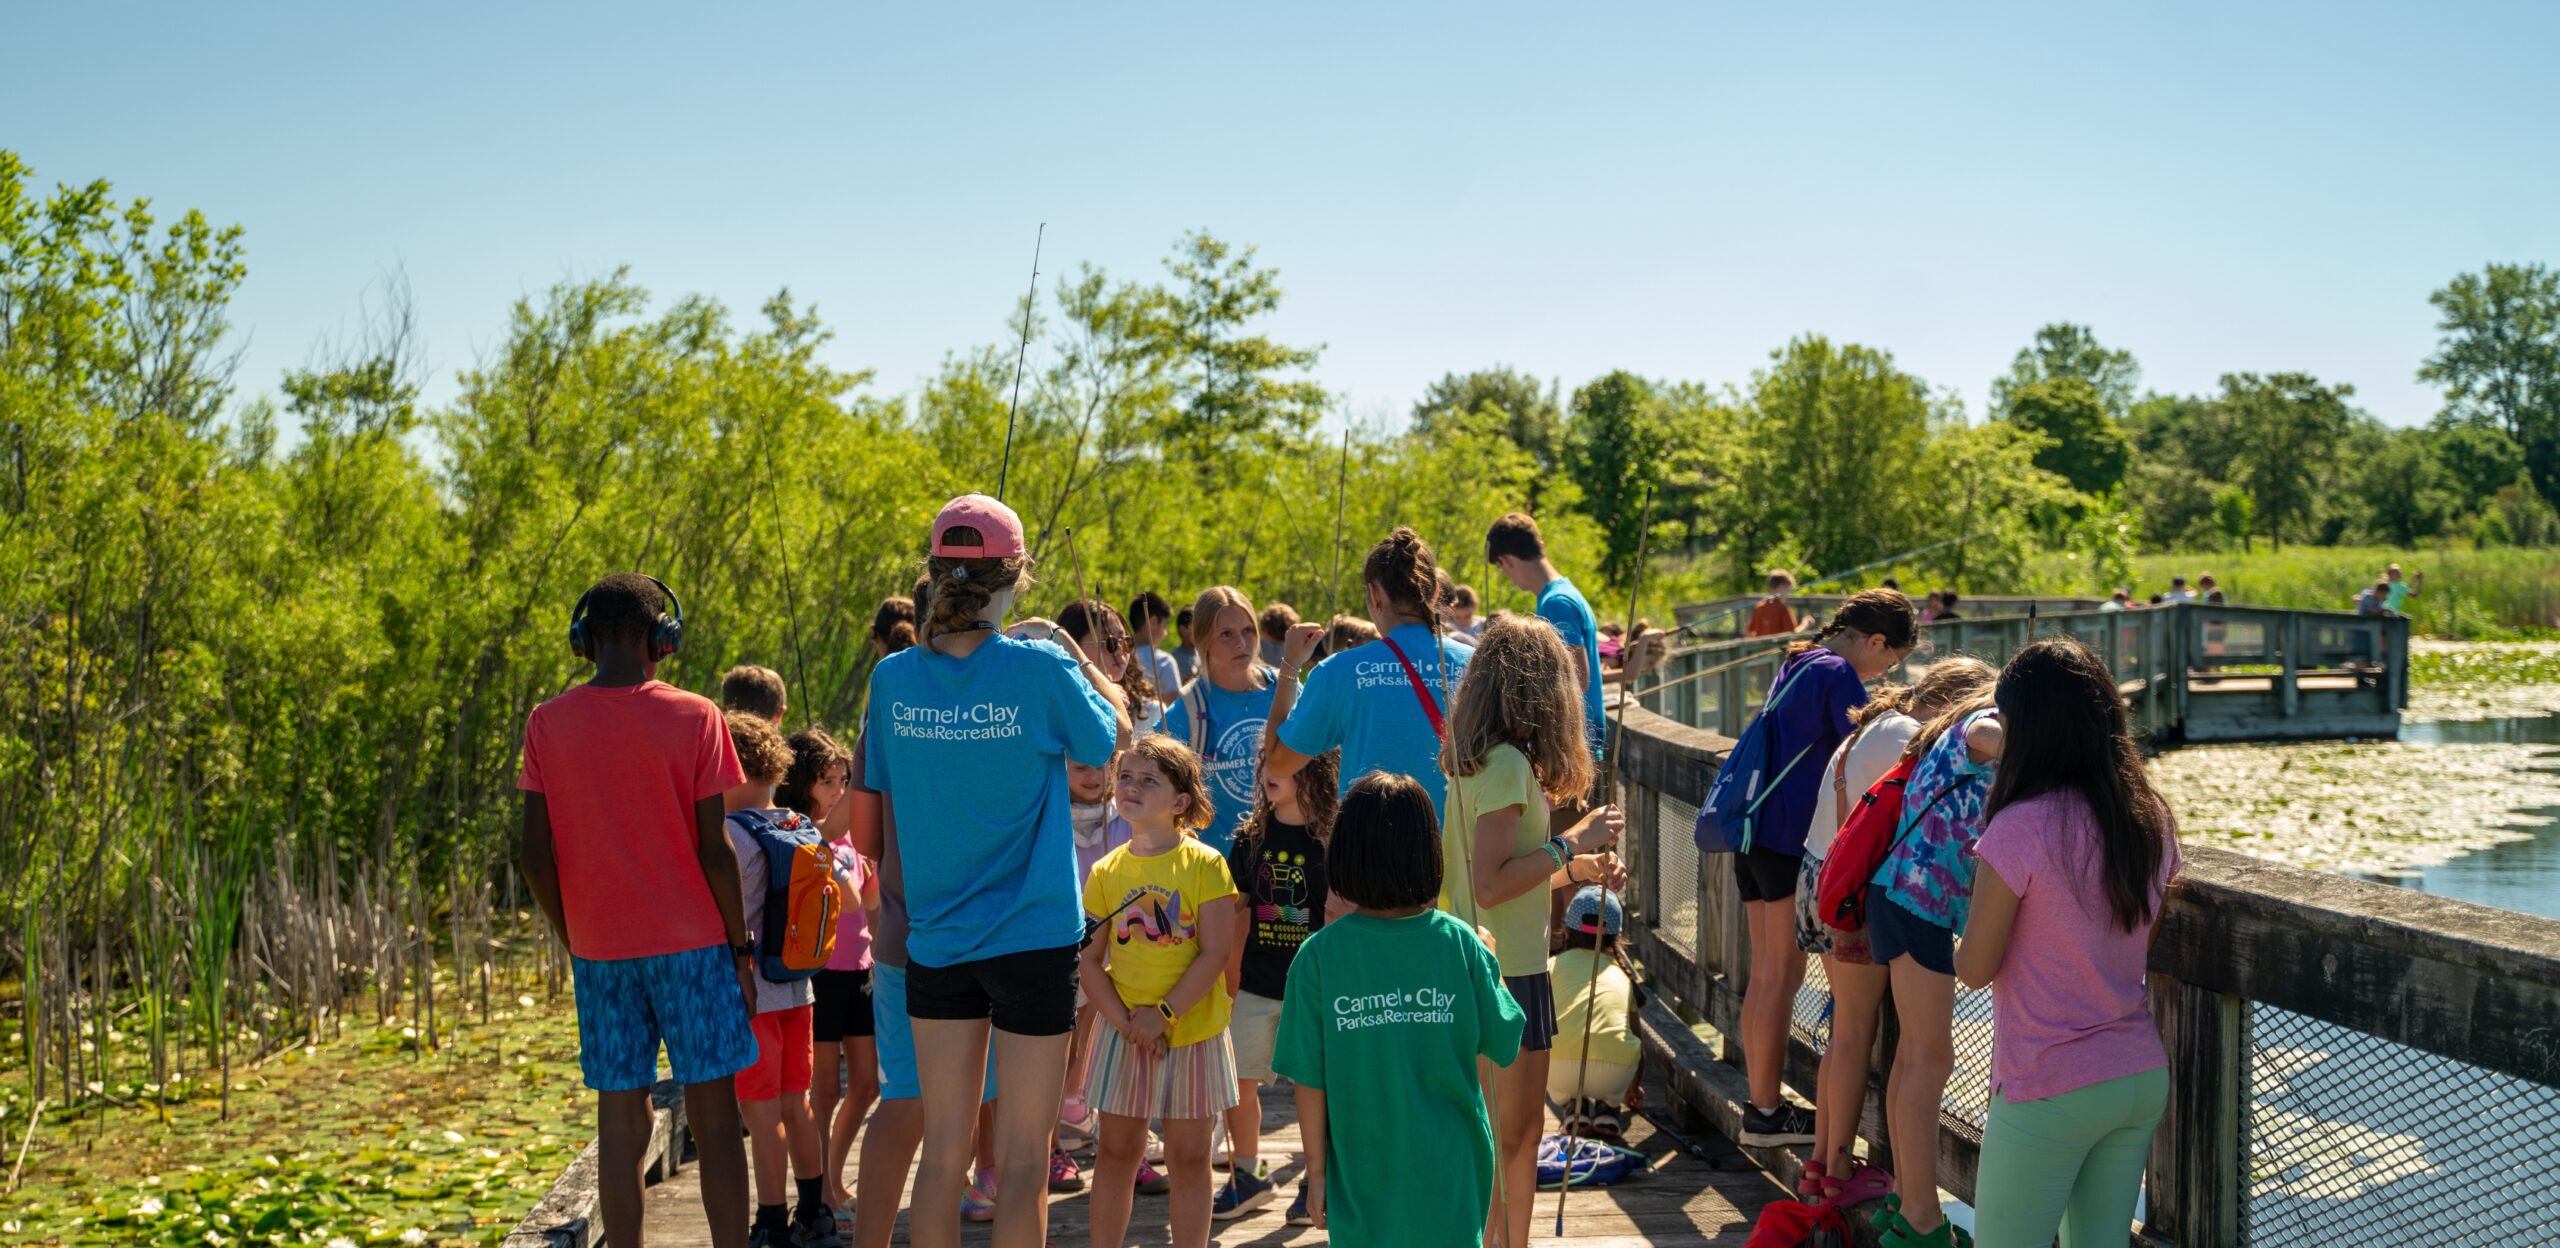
2417,263,2560,504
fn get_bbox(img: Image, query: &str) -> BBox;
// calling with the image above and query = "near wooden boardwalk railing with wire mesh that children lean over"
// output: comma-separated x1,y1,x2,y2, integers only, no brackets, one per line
1618,695,2560,1245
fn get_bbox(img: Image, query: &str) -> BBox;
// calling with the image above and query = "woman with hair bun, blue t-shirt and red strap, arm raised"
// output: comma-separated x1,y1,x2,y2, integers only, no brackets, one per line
1265,527,1475,813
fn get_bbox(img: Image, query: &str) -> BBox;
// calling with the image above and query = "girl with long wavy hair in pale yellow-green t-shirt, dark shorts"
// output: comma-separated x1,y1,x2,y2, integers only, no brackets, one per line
1441,614,1626,1243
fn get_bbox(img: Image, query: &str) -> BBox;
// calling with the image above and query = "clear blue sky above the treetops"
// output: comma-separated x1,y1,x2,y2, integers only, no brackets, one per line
0,3,2560,425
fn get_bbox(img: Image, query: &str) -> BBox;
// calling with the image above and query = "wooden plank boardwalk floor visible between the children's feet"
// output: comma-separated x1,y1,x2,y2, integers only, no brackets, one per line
648,1063,1787,1248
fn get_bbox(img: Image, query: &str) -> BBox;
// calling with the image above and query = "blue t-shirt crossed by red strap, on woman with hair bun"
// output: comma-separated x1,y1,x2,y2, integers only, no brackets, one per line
1280,624,1475,818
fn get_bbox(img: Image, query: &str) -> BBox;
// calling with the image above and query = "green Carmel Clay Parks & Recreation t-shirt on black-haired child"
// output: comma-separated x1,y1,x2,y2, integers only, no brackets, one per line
1272,905,1526,1245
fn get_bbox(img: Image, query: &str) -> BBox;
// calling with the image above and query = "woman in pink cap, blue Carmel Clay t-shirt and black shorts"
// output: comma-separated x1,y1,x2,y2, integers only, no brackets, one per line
863,494,1129,1248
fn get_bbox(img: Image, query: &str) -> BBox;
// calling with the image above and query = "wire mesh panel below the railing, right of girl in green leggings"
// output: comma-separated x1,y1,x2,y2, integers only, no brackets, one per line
2240,1005,2560,1248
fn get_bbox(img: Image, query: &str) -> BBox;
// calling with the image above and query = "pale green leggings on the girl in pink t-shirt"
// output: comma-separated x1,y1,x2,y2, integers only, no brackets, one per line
1974,1069,2168,1248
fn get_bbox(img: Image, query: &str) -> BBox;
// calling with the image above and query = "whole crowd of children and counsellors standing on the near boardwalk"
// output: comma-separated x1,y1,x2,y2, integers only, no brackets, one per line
520,496,2176,1248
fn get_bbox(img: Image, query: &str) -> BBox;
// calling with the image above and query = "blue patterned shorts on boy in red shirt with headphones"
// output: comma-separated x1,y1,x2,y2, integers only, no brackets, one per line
583,944,755,1092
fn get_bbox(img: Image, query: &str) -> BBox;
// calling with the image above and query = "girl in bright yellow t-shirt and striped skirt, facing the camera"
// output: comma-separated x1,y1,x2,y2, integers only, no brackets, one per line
1083,737,1236,1248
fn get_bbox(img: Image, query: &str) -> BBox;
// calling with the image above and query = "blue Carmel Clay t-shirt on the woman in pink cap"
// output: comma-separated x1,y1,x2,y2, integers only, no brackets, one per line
863,634,1119,967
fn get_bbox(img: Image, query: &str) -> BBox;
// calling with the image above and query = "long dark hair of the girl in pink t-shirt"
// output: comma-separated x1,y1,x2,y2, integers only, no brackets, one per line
1981,637,2176,931
